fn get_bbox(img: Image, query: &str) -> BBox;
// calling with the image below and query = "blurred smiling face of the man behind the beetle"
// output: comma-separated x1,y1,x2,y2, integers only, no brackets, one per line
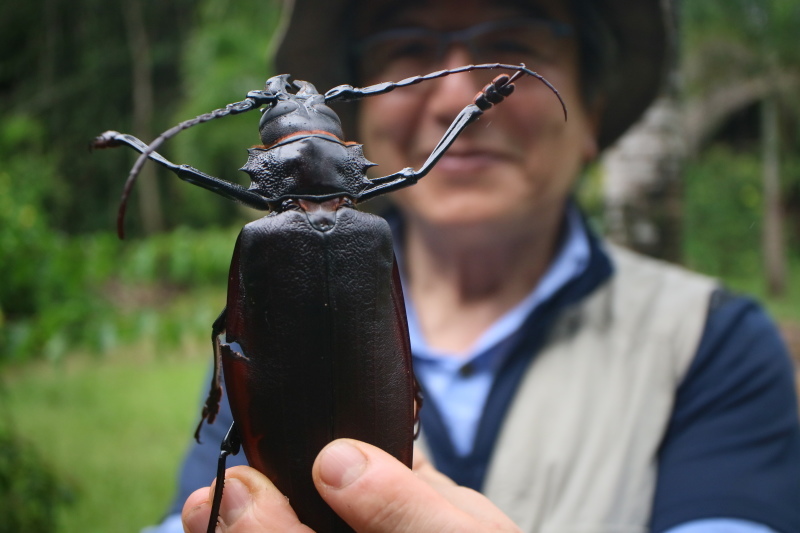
359,0,597,235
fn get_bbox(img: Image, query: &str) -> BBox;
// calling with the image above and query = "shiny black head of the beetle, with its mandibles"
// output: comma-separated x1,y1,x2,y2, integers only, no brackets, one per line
258,74,344,146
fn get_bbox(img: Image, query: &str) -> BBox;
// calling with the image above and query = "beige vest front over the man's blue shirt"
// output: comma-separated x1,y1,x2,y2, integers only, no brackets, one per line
418,247,716,533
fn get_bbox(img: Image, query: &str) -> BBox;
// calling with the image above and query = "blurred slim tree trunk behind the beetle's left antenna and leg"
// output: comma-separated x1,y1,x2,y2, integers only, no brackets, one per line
122,0,164,234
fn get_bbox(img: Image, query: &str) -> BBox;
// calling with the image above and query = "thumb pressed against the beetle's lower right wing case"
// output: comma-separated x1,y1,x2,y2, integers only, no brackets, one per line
312,439,479,533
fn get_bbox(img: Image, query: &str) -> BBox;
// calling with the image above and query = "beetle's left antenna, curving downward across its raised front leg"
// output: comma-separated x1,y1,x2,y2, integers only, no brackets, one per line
117,91,277,239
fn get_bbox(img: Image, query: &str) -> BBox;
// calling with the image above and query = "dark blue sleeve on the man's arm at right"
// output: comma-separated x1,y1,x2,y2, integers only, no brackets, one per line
651,294,800,533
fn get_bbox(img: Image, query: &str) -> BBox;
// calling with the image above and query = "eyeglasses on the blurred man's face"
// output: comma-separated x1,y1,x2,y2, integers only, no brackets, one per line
353,18,573,81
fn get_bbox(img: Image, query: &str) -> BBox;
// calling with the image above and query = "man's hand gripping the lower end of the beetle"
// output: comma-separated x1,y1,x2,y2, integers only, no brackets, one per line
182,439,519,533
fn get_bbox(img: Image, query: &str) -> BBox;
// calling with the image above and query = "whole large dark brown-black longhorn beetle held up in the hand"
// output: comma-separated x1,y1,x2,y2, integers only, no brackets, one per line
94,63,566,533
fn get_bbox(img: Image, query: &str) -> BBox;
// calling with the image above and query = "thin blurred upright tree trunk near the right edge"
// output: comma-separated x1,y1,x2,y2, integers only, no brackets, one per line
761,94,786,296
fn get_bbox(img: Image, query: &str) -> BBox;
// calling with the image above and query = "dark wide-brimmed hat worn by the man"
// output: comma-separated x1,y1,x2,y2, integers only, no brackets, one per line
272,0,670,149
